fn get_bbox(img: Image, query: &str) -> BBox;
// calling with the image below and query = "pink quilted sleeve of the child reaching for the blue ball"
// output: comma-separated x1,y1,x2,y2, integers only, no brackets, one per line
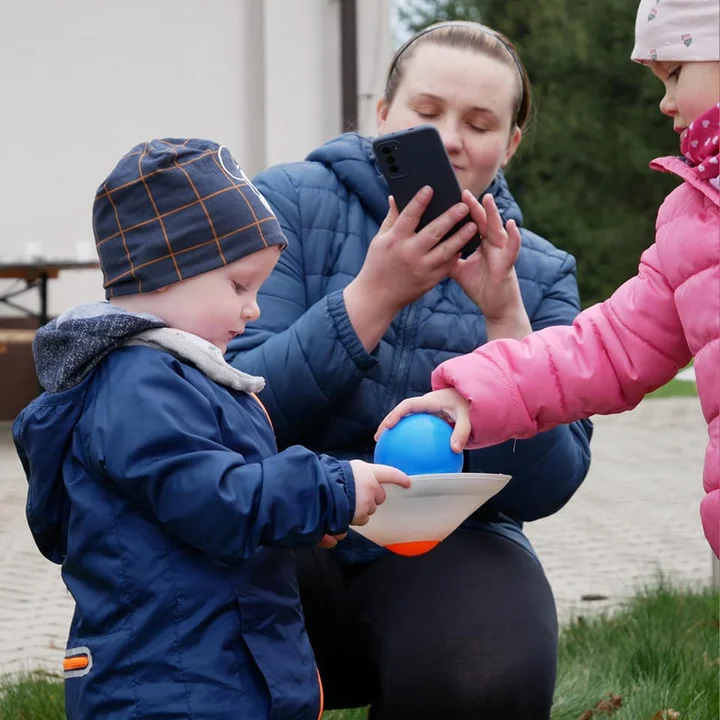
433,245,691,447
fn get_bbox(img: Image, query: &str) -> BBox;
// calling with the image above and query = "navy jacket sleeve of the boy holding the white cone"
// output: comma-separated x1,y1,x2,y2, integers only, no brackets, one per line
88,353,355,562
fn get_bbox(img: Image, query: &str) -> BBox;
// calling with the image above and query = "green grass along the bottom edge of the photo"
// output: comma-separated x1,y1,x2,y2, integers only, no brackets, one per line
0,582,720,720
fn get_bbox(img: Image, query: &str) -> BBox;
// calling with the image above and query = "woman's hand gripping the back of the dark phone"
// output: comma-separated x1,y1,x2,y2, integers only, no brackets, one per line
343,186,477,351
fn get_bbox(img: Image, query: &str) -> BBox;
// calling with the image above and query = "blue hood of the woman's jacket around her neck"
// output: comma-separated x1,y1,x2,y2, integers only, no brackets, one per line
307,133,522,225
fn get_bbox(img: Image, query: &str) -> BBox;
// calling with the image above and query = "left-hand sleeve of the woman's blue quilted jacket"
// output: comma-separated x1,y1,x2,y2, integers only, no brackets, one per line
227,168,377,447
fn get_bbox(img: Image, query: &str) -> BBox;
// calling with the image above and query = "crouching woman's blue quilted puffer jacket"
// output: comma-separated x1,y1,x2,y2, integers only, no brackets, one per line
228,134,592,562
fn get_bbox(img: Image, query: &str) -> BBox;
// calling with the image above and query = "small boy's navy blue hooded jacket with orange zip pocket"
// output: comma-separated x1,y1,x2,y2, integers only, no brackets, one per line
13,312,354,720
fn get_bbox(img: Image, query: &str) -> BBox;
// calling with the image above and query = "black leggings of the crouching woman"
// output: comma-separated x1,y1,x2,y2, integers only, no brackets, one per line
297,530,557,720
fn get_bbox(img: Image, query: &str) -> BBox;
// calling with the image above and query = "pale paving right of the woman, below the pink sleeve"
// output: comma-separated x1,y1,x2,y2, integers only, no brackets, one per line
526,398,713,620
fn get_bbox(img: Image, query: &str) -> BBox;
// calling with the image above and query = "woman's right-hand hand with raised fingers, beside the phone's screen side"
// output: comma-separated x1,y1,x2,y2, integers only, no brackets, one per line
450,190,532,340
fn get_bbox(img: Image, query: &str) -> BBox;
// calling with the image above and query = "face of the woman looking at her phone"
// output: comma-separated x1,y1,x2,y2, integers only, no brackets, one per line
377,43,522,197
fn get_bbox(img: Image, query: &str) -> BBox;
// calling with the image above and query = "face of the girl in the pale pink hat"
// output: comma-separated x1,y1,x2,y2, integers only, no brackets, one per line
648,61,720,133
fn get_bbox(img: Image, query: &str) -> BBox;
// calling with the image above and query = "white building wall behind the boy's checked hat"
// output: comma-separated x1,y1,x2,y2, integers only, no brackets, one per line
0,0,390,314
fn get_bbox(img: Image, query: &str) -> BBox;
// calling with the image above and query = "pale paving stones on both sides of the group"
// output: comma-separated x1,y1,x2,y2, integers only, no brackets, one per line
0,398,711,673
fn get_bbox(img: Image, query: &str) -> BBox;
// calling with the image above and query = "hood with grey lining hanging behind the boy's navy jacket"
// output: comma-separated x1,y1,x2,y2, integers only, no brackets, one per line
13,303,165,563
